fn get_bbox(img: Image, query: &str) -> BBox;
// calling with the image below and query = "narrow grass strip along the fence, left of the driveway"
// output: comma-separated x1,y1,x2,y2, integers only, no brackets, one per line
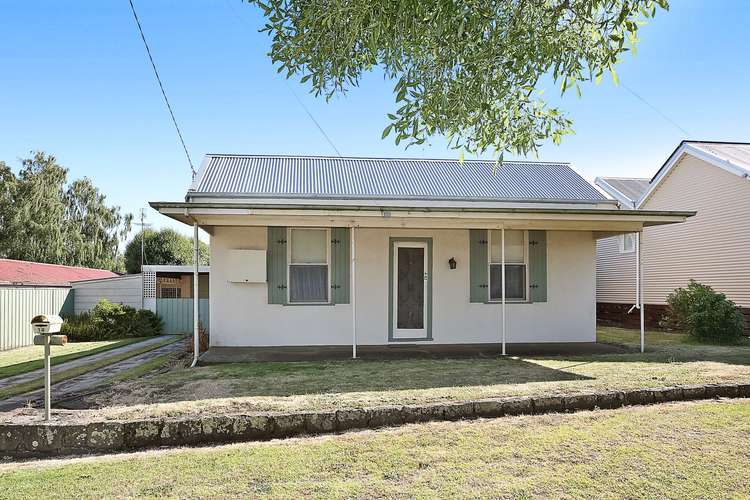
0,337,148,379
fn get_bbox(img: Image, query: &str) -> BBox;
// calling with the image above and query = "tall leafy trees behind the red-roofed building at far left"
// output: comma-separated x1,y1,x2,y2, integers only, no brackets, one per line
0,151,132,270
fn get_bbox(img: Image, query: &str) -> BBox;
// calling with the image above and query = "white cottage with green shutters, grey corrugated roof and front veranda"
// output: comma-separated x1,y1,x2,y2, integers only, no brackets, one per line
151,154,692,355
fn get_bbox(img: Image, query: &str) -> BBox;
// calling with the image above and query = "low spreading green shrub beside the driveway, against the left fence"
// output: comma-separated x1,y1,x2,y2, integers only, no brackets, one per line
62,299,163,342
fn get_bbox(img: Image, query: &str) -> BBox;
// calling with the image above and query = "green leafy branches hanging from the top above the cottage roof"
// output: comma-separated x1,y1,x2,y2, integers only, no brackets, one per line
248,0,669,155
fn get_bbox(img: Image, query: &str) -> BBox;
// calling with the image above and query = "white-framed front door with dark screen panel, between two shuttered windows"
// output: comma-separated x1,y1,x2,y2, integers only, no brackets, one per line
391,241,429,340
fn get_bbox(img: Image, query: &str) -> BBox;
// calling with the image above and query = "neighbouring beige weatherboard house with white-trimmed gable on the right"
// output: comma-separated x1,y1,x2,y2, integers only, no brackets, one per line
596,141,750,326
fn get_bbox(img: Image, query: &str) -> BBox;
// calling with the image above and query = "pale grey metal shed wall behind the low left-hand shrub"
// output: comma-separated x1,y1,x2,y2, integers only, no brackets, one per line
72,274,143,314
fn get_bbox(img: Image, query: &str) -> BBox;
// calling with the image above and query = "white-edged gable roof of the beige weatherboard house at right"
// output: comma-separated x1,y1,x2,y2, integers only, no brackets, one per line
638,141,750,207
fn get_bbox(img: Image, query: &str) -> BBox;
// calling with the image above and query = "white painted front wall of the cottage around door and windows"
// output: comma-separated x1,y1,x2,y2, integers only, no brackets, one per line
210,226,596,346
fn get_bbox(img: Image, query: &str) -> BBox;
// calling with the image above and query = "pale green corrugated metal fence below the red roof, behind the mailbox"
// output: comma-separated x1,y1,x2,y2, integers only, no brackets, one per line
0,286,73,351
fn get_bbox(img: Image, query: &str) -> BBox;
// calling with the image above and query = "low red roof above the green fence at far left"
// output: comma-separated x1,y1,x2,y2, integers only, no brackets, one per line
0,259,118,286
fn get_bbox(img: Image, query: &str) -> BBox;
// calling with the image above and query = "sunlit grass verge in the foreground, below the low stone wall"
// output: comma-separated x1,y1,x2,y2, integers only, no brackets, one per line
0,400,750,499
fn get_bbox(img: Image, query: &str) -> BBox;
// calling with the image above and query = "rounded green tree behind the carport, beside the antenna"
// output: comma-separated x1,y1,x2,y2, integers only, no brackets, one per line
125,228,209,273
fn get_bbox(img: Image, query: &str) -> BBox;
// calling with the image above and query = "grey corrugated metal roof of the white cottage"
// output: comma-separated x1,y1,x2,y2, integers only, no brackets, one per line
191,155,605,202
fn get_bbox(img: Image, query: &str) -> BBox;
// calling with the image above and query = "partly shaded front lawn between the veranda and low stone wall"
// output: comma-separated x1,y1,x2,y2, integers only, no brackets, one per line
78,329,750,419
